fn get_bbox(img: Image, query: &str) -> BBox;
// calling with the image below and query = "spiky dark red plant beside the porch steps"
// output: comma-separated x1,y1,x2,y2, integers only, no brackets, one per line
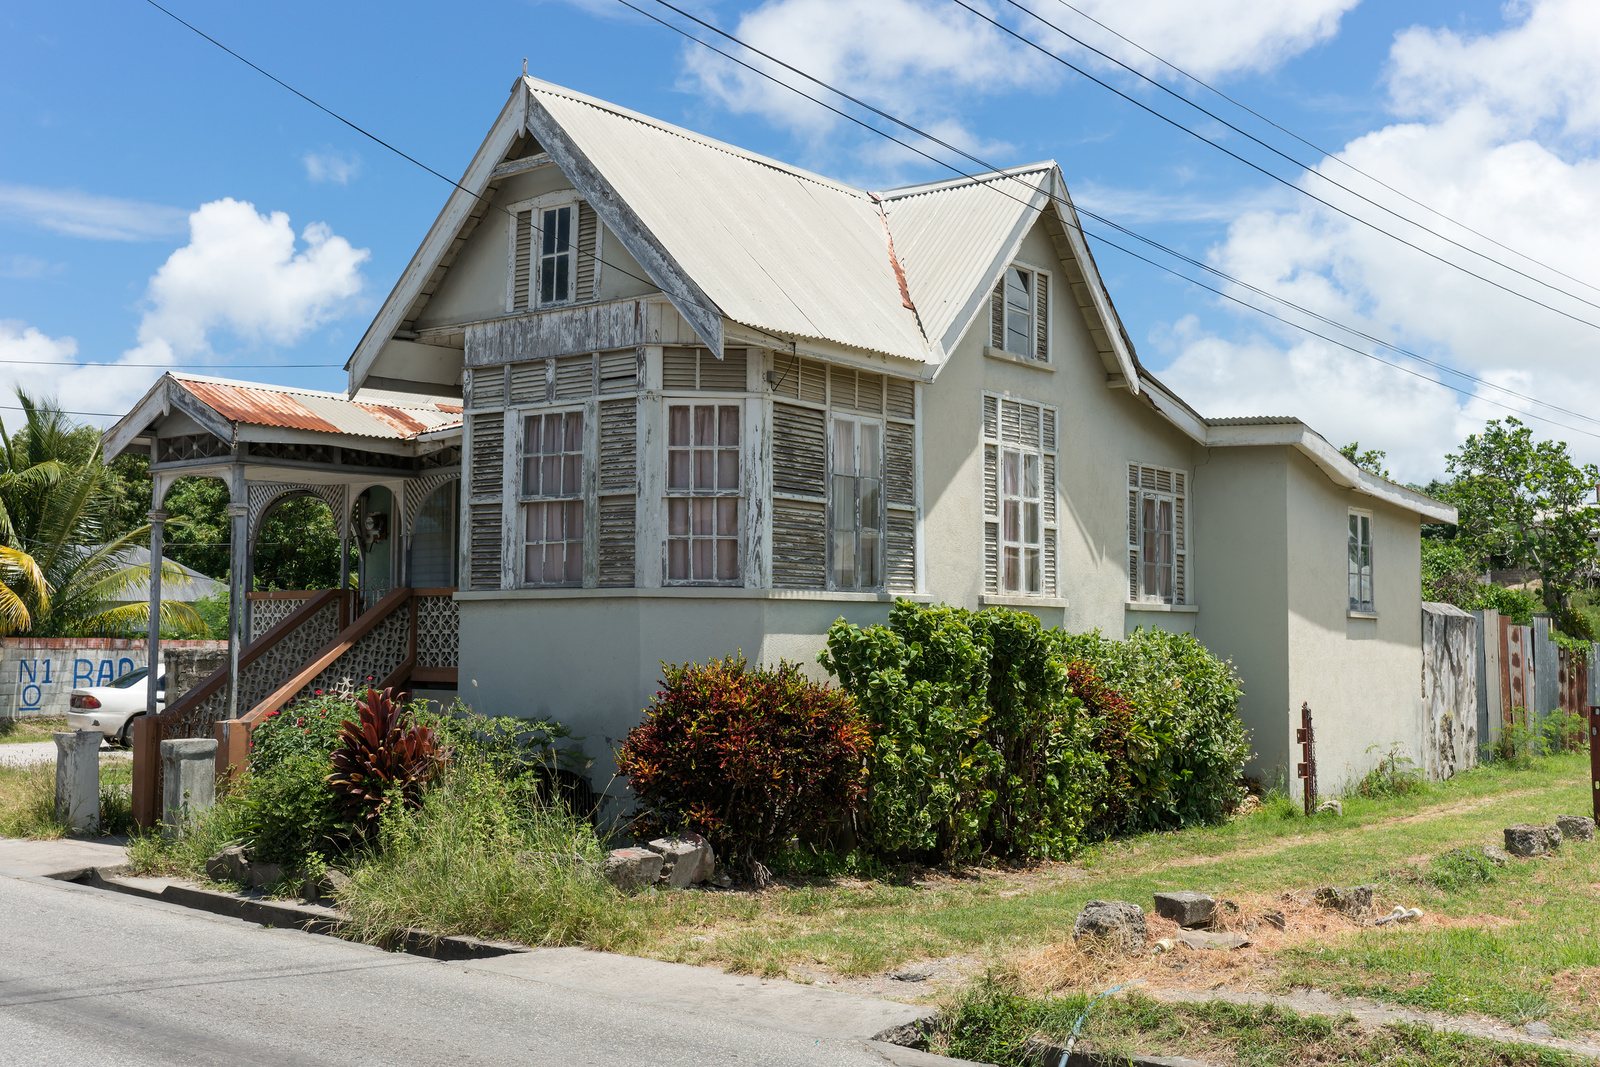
328,689,446,837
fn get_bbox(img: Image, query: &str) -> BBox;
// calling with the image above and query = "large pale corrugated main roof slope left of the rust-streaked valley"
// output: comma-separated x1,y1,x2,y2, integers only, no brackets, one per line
526,78,928,360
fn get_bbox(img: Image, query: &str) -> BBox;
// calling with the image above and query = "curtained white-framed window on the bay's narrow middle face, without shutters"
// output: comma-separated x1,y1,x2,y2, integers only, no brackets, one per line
667,403,741,584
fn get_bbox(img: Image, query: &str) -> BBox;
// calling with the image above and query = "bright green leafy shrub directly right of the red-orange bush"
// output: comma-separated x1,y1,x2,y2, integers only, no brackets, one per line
819,600,1099,859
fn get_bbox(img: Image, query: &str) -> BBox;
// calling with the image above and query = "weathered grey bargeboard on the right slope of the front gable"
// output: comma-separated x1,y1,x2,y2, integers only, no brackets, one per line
522,82,723,358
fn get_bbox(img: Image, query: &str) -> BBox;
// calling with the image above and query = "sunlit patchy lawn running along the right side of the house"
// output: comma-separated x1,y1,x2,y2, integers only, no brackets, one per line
592,753,1600,1032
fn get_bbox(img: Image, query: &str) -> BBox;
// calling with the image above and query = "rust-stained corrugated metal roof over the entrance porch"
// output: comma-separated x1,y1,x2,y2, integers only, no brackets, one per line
171,374,461,440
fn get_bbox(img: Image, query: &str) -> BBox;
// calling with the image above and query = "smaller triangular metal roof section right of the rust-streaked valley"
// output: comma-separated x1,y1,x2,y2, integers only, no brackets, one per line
883,163,1054,350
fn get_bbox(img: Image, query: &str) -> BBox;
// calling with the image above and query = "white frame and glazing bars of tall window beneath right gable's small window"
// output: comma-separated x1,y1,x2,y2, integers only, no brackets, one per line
979,394,1061,598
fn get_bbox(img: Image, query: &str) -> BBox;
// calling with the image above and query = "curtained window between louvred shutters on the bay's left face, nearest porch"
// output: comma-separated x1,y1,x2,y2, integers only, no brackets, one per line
522,411,584,585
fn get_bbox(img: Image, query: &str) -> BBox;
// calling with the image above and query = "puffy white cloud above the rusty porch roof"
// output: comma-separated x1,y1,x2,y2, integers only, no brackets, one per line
128,198,371,362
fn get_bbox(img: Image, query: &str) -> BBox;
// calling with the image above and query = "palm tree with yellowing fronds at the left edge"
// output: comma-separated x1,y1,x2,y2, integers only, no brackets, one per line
0,390,205,637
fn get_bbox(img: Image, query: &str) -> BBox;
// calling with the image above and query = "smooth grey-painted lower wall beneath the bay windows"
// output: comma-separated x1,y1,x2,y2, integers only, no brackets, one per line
456,589,915,795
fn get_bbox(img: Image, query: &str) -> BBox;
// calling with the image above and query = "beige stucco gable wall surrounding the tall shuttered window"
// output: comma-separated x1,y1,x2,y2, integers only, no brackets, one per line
922,215,1194,637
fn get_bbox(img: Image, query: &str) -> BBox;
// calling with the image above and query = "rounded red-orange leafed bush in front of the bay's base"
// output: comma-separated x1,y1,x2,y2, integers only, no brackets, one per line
618,656,867,880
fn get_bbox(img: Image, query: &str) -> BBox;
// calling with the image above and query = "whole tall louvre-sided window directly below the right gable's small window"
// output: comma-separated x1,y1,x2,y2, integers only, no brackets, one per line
984,395,1056,597
